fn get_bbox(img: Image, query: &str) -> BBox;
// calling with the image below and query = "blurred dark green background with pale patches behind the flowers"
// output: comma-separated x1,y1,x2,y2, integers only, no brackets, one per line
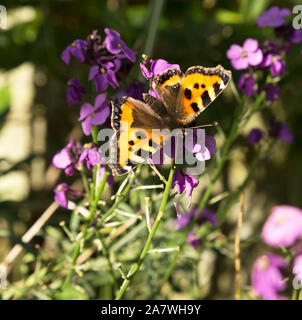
0,0,302,299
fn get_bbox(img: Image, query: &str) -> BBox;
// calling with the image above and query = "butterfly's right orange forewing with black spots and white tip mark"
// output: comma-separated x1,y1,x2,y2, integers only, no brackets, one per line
176,65,231,125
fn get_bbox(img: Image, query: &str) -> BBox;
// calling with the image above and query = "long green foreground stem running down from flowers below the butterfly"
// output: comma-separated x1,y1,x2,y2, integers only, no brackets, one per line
116,164,175,300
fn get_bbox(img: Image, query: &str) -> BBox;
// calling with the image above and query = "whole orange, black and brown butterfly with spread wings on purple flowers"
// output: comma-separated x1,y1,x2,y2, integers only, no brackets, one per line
109,65,231,175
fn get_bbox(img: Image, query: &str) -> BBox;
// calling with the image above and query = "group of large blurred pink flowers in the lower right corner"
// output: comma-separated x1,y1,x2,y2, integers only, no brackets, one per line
251,205,302,300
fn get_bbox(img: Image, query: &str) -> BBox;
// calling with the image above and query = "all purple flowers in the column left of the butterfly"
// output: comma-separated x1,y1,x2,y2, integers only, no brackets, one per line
52,28,138,208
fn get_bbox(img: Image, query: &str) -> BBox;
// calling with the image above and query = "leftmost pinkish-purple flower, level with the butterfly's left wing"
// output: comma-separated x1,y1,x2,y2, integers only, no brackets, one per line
52,137,83,176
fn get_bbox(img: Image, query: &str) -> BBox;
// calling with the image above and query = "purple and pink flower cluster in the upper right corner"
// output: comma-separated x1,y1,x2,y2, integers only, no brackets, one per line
227,6,302,102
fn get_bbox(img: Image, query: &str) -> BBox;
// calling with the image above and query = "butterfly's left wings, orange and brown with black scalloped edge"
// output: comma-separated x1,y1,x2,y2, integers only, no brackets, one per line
109,97,168,175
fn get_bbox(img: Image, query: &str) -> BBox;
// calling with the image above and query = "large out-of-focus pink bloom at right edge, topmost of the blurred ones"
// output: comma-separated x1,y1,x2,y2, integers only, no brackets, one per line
261,206,302,248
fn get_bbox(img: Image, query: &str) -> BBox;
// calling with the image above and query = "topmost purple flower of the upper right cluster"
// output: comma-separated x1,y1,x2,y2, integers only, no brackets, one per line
257,6,291,28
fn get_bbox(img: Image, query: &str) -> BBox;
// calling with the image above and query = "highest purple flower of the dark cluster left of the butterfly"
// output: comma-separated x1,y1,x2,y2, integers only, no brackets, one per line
104,28,136,62
